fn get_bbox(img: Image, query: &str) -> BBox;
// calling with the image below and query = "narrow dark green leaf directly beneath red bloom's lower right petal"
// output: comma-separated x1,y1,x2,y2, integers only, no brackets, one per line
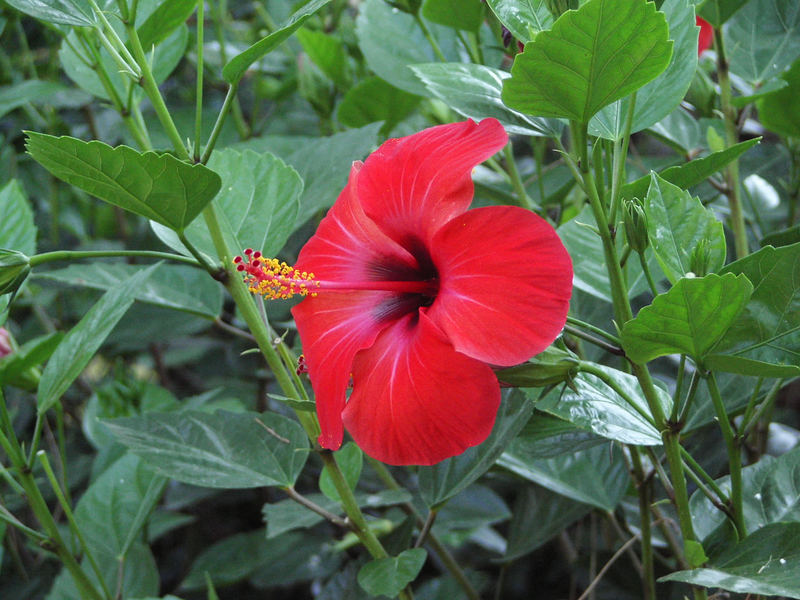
418,390,533,508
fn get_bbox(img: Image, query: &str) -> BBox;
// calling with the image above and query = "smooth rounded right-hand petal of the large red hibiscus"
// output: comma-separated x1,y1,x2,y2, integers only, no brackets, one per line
427,206,572,366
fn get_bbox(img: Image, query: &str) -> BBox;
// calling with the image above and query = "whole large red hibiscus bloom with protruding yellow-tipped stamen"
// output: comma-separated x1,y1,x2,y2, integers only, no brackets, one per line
234,119,572,465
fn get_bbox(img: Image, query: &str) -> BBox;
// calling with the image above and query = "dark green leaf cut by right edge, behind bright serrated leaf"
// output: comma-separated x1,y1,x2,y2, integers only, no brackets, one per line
714,244,800,366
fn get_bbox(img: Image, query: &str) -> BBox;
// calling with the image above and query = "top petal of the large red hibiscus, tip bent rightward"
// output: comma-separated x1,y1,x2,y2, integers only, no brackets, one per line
357,119,508,248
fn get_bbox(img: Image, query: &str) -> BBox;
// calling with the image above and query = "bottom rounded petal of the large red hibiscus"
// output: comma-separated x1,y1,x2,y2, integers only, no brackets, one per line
343,314,500,465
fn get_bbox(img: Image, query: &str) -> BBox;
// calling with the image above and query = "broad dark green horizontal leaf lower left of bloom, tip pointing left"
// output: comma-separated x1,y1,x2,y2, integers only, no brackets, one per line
105,410,308,489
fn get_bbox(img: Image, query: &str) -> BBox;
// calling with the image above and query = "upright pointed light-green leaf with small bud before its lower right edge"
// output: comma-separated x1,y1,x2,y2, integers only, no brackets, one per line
645,173,727,283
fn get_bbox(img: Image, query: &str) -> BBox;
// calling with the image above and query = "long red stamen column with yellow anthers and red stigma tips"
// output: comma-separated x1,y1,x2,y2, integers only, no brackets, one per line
233,248,439,306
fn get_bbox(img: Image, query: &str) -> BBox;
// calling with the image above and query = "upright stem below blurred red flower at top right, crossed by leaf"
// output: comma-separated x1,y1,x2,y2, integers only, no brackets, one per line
714,27,750,259
